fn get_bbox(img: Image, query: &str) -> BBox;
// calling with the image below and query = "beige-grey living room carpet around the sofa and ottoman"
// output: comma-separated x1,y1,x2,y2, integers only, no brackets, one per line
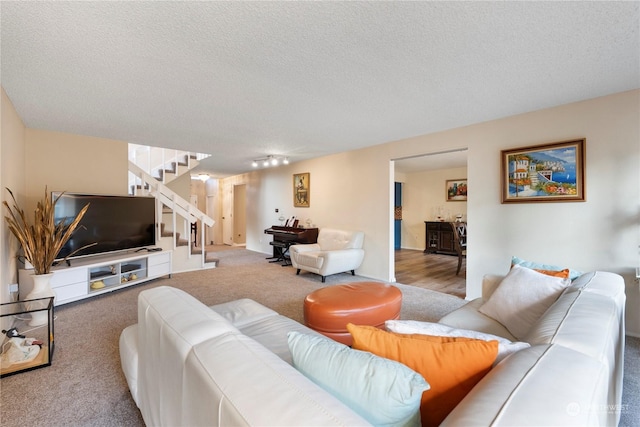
0,248,640,427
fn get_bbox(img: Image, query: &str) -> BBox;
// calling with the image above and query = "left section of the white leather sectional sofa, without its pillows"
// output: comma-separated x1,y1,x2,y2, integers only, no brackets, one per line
120,287,367,426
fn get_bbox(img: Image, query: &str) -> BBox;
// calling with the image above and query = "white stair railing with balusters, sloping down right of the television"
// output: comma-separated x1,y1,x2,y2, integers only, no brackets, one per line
129,161,215,267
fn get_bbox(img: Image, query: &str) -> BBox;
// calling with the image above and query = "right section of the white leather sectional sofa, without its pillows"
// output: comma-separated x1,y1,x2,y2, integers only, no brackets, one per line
440,271,626,426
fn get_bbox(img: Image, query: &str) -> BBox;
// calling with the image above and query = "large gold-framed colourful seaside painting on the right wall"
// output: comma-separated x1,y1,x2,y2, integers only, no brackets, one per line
500,139,585,203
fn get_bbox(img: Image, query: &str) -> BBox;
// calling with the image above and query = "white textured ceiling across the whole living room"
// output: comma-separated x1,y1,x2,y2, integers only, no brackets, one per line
0,1,640,176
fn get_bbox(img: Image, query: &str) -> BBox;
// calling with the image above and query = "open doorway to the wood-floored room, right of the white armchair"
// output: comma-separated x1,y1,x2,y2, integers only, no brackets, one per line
390,148,468,298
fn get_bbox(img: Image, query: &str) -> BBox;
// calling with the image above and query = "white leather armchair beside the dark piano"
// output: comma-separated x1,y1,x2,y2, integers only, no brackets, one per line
289,228,364,283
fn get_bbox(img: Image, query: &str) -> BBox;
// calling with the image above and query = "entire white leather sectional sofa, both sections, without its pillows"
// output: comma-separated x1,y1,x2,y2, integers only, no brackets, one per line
120,272,625,426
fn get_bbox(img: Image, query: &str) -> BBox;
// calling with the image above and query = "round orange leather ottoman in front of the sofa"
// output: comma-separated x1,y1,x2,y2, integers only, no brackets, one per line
304,282,402,345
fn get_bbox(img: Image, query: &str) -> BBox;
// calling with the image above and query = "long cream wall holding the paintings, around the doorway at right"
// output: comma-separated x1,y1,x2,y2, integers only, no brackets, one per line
241,90,640,335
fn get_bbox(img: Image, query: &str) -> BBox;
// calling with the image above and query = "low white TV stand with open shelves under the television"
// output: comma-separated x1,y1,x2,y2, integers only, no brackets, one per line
18,250,172,305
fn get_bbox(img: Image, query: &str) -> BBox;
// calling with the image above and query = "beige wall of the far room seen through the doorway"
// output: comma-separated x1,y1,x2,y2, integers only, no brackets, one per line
395,167,467,250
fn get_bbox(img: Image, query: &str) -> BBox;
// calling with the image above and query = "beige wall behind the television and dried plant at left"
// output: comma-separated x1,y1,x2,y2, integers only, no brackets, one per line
0,115,128,301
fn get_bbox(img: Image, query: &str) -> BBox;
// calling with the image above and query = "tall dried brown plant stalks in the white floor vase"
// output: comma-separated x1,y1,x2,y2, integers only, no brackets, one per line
3,187,95,274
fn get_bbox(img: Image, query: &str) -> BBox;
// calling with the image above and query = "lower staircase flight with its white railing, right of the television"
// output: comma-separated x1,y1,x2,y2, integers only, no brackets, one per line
129,160,218,273
